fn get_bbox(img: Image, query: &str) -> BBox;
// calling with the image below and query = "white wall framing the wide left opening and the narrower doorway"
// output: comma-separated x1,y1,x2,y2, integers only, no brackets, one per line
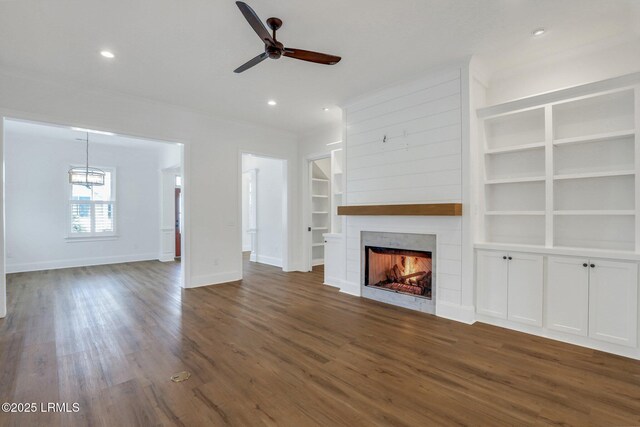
0,70,299,297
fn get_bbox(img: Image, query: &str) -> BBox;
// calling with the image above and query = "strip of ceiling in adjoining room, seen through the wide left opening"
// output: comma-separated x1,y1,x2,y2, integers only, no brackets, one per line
4,119,177,151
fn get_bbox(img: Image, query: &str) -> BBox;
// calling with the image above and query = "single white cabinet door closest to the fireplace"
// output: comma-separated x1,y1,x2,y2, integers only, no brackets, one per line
476,251,507,319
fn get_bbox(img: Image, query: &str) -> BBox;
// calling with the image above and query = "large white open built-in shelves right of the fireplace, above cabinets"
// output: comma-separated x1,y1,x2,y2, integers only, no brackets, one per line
480,87,640,252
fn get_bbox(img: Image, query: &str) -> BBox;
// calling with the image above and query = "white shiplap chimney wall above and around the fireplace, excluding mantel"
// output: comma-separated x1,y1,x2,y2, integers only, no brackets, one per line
343,68,462,308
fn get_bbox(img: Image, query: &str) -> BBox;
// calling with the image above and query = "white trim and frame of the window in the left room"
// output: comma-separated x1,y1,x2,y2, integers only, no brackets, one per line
65,165,120,243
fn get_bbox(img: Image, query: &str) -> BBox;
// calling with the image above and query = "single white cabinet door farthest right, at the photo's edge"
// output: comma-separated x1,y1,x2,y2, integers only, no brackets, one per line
589,260,638,347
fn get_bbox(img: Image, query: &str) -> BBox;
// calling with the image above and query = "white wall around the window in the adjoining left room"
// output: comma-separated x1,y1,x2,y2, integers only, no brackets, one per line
4,134,164,272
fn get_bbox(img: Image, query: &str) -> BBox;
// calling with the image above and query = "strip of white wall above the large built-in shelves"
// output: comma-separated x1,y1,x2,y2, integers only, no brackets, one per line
487,39,640,105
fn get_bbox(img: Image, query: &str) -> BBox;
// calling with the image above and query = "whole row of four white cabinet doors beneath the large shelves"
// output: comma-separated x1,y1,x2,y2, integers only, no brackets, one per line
476,250,638,347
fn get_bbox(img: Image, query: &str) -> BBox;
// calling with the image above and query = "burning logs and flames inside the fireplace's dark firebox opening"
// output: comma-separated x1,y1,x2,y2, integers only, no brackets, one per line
364,246,432,299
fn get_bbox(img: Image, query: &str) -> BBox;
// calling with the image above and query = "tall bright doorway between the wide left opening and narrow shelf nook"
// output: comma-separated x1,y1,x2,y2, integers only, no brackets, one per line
240,153,288,269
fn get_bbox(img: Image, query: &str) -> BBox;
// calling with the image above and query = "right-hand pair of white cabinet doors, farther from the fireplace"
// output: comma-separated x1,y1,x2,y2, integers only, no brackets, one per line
546,257,638,347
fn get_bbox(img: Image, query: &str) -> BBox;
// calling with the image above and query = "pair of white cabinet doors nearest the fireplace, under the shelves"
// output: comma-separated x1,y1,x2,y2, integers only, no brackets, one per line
476,251,543,326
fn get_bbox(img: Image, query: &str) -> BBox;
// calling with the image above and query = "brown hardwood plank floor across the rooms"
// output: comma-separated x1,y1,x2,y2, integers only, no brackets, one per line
0,262,640,427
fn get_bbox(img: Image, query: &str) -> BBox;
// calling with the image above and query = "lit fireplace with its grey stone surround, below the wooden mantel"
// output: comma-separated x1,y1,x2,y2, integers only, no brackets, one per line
361,231,436,313
